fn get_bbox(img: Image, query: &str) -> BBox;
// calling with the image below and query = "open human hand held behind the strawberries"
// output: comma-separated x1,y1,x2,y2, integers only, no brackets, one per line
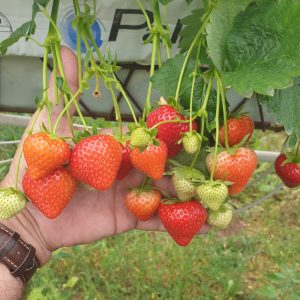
1,48,208,264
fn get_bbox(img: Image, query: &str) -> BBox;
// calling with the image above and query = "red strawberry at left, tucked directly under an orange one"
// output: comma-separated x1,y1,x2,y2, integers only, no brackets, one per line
23,168,76,219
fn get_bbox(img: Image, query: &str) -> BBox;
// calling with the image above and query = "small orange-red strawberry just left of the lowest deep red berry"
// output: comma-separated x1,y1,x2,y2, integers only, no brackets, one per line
125,189,161,221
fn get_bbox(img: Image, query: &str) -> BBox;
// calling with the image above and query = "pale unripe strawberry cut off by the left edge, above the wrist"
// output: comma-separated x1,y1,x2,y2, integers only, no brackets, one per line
0,188,27,220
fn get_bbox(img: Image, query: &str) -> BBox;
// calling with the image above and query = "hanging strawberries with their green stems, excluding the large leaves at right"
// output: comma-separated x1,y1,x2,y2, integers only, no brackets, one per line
0,0,300,246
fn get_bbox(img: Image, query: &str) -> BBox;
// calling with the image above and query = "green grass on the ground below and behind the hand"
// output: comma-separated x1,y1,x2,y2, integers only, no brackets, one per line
0,123,300,300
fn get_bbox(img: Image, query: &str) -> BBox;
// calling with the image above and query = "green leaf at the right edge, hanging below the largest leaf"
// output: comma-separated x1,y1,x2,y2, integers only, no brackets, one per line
258,77,300,138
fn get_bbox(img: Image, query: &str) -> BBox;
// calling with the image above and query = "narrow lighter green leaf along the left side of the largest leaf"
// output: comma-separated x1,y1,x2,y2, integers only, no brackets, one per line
206,0,253,70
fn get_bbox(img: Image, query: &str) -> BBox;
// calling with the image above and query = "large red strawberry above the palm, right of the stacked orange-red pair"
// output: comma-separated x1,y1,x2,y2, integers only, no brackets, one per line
70,134,122,191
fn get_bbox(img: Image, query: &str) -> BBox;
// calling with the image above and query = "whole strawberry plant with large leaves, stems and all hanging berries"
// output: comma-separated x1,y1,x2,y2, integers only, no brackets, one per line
0,0,300,246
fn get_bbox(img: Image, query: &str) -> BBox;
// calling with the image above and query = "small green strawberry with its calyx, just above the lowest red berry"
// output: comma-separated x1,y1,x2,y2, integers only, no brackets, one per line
172,167,204,202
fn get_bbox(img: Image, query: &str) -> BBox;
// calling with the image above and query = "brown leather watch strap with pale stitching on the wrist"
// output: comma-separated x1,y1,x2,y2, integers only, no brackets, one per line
0,224,40,283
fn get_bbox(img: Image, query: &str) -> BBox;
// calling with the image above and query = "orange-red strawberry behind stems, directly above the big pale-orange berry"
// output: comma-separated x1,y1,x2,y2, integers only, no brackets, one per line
220,115,254,146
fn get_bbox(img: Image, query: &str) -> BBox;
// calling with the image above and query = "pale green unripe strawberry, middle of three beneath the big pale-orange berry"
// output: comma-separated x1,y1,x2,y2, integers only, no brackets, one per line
197,181,228,210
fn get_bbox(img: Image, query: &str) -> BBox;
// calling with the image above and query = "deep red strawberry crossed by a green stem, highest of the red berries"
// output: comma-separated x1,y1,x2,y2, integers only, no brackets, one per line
147,105,198,157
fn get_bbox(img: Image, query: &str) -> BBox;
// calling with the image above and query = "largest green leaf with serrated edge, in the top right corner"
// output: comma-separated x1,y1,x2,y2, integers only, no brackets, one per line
223,0,300,97
